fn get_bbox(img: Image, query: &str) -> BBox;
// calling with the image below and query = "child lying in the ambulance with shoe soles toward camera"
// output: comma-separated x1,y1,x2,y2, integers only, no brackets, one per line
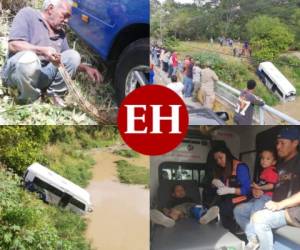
150,184,218,227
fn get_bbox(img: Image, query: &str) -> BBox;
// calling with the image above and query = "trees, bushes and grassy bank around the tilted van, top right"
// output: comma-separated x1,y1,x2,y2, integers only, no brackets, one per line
151,0,300,105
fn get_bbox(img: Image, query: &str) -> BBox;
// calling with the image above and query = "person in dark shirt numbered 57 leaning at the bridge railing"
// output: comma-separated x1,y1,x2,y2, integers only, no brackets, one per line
233,80,265,125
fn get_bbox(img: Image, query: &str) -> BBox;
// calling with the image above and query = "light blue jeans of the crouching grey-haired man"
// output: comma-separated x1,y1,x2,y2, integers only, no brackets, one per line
4,49,81,103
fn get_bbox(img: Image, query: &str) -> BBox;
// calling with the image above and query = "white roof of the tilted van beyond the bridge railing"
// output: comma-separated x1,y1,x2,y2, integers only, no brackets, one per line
259,62,296,93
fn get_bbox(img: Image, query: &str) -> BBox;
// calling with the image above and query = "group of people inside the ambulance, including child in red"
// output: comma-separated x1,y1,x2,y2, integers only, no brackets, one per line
150,126,300,250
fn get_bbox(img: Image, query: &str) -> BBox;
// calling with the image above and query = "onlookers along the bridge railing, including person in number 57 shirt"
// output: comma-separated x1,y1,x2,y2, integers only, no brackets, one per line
151,44,265,125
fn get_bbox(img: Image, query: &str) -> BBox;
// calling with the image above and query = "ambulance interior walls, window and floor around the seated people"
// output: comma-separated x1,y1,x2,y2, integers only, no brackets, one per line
150,126,300,250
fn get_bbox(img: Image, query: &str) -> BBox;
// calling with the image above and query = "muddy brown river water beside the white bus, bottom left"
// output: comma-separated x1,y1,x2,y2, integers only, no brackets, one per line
86,150,149,250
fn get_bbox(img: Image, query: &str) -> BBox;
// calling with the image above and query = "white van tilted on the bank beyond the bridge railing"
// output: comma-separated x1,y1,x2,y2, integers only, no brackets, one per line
257,62,296,101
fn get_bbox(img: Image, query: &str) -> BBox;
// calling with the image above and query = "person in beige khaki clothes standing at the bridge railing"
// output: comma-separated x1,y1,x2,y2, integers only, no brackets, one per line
198,62,219,109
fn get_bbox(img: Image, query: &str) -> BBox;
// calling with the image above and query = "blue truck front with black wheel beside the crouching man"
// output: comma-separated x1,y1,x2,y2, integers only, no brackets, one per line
70,0,150,104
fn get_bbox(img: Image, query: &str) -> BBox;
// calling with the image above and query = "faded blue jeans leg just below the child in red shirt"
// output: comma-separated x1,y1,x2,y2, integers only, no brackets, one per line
233,195,271,241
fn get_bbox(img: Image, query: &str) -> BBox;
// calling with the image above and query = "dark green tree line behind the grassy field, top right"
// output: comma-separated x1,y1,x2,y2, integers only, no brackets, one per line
151,0,300,48
